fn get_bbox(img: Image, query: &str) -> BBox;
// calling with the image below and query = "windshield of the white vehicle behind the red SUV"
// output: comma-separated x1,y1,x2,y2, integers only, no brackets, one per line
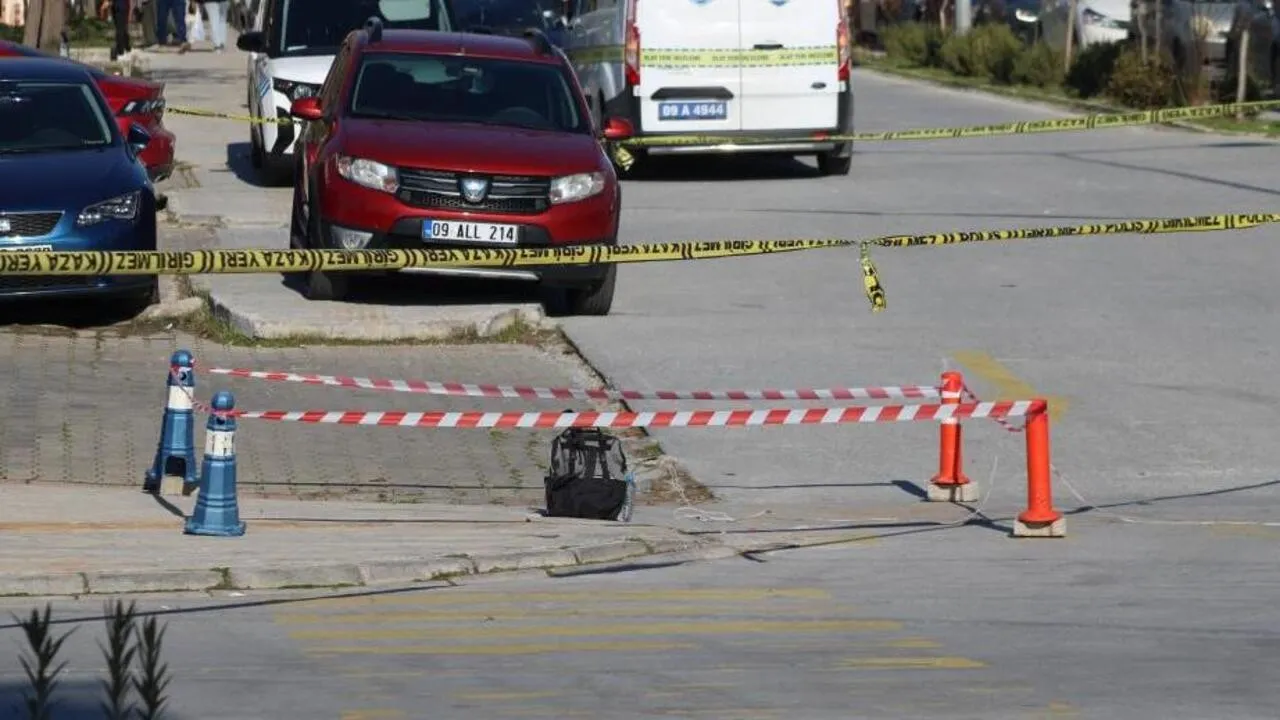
271,0,453,56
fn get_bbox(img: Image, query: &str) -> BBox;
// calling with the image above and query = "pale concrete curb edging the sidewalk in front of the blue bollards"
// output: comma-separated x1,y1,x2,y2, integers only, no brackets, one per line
0,538,736,598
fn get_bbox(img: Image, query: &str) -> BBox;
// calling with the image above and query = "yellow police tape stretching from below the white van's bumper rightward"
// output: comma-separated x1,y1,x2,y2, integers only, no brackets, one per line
612,100,1280,169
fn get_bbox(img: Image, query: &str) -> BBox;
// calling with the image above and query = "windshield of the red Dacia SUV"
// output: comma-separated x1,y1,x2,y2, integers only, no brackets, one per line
349,53,590,132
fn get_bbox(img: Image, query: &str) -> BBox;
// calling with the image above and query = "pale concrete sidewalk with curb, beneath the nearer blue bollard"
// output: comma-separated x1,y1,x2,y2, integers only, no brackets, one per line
0,484,732,596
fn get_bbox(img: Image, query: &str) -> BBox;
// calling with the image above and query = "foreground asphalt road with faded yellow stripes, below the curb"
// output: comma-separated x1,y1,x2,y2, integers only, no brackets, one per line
0,515,1280,720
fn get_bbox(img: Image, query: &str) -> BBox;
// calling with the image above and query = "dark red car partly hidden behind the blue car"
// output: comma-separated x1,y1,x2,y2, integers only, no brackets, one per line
0,40,177,182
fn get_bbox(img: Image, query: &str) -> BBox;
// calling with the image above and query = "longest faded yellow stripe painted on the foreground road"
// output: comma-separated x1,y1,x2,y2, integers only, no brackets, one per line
289,620,902,641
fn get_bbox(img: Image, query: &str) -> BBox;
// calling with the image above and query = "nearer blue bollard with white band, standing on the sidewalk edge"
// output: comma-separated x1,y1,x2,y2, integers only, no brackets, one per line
184,391,244,537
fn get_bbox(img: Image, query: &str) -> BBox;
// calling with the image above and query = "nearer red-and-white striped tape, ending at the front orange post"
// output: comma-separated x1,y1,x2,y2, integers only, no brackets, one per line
230,400,1046,429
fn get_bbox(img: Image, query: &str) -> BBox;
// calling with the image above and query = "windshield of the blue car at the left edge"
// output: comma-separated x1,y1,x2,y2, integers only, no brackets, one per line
0,81,114,155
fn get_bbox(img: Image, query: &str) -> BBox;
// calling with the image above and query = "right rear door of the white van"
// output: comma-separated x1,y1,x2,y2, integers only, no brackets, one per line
737,0,840,131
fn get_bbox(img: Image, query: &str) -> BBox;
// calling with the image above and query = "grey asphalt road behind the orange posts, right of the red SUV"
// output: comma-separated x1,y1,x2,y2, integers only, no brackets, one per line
566,72,1280,519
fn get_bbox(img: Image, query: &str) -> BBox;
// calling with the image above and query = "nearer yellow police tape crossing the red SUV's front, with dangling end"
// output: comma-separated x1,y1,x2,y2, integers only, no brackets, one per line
0,213,1280,311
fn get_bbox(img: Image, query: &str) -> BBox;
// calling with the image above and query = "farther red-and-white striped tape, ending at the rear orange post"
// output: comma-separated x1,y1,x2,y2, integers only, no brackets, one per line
205,368,940,400
